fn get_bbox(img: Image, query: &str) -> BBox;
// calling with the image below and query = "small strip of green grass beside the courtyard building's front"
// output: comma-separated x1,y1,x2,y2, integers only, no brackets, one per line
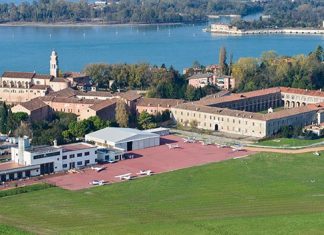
255,138,324,147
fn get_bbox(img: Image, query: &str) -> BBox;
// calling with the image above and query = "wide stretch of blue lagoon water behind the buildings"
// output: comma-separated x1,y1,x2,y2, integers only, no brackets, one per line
0,25,324,73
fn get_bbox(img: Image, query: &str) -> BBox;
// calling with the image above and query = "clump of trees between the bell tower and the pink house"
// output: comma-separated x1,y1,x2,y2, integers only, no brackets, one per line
84,64,219,100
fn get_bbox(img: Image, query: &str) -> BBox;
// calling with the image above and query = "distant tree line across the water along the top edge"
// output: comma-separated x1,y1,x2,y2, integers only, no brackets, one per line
0,0,261,23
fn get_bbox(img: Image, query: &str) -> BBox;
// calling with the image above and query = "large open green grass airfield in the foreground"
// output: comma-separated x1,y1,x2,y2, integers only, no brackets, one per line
0,153,324,235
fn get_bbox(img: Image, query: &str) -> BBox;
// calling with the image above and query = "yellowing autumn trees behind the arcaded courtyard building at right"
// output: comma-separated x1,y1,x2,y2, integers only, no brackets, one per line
232,46,324,91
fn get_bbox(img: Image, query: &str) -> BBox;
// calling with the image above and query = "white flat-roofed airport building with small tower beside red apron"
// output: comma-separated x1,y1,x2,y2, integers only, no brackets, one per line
0,138,97,182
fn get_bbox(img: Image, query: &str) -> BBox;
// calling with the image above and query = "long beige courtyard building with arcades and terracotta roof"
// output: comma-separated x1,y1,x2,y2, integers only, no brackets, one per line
171,87,324,138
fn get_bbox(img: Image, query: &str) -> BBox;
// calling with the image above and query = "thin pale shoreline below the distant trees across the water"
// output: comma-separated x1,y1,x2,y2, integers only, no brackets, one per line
0,22,185,27
